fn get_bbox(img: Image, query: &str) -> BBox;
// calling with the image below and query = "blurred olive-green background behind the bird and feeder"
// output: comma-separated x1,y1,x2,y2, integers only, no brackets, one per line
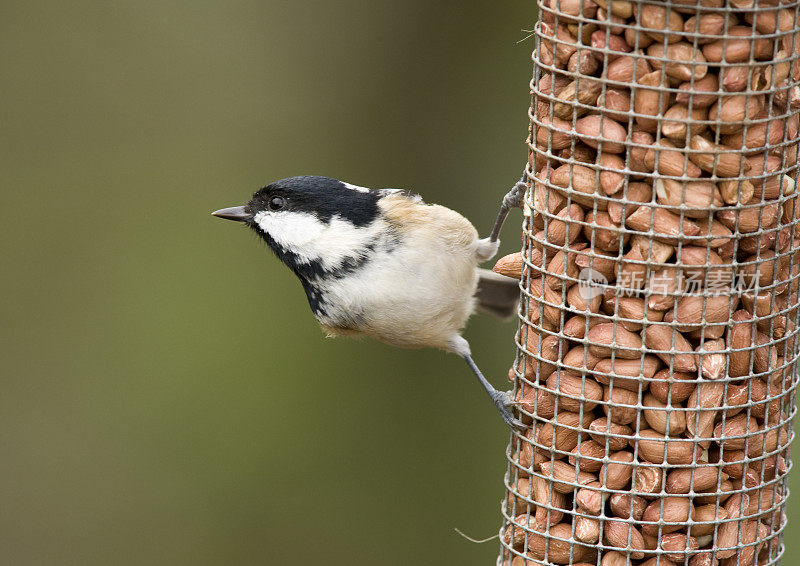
0,0,797,566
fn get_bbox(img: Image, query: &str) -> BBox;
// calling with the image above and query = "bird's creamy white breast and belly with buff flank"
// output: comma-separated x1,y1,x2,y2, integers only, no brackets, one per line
319,199,478,349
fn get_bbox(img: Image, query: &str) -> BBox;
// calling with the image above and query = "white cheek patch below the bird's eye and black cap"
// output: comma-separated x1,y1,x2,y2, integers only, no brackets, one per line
254,210,385,269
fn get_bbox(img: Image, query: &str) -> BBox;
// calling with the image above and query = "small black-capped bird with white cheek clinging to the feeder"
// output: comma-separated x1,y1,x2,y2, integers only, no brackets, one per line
211,174,527,430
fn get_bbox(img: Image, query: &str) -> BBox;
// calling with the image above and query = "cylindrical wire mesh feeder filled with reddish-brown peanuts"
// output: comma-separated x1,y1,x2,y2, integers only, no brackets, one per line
496,0,800,566
